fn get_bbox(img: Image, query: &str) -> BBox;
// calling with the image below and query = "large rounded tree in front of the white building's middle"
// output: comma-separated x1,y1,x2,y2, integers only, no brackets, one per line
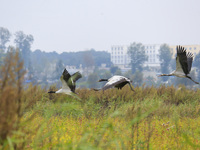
128,42,148,73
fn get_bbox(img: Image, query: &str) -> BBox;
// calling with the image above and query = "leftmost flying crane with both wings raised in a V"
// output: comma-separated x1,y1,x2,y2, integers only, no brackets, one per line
48,69,82,99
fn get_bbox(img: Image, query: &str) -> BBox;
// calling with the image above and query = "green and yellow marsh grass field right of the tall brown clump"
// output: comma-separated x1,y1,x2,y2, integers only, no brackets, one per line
19,86,200,149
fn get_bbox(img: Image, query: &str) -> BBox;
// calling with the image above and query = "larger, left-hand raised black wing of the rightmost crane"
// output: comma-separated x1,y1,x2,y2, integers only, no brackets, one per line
176,45,189,75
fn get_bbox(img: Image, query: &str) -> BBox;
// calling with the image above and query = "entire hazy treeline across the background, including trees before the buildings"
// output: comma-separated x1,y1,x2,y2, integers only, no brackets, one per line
0,27,200,88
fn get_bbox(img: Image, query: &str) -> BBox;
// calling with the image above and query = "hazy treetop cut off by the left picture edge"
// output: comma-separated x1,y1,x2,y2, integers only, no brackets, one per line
0,27,11,51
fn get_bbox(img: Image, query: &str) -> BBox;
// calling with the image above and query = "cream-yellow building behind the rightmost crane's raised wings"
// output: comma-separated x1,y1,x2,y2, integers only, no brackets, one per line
169,44,200,58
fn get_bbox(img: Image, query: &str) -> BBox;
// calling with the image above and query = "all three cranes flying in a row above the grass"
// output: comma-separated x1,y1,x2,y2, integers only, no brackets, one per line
48,46,199,95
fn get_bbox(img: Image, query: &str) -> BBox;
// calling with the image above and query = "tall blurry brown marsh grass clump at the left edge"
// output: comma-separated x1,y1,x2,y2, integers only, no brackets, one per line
0,49,42,149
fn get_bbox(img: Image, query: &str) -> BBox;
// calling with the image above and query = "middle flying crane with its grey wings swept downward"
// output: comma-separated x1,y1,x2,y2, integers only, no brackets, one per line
94,75,134,91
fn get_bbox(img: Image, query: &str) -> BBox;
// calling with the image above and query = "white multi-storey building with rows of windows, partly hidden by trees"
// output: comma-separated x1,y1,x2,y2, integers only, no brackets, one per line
111,44,160,69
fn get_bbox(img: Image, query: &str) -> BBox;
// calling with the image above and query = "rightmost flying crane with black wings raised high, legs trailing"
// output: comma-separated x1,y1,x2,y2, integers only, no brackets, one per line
159,45,199,84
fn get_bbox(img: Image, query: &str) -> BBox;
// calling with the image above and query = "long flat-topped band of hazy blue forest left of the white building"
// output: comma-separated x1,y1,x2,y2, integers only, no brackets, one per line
31,49,112,68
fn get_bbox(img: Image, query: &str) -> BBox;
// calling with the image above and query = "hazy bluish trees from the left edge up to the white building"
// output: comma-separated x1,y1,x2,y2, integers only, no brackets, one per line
0,27,112,83
